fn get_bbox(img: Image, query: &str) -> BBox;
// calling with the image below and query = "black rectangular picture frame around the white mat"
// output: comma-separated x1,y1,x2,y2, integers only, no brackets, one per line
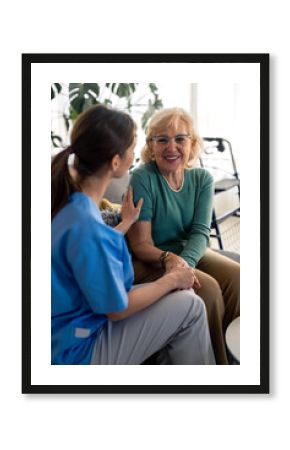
22,53,270,394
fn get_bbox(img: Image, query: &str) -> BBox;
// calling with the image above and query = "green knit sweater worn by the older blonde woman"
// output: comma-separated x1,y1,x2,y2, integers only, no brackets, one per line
130,162,213,267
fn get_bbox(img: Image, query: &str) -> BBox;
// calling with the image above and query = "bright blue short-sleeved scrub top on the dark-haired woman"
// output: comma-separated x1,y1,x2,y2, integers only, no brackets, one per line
51,192,133,364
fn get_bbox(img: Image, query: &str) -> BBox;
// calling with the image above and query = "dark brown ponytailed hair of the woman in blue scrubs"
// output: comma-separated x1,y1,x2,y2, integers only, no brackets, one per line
51,105,135,219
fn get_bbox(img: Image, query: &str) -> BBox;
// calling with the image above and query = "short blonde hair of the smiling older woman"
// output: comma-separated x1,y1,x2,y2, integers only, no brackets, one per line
141,108,202,169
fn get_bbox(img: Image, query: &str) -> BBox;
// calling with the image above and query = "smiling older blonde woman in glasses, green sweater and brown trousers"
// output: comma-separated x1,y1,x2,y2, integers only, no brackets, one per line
128,108,240,364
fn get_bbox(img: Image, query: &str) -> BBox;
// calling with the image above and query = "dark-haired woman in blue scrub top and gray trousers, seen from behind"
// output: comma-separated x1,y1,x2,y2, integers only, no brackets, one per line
51,105,215,364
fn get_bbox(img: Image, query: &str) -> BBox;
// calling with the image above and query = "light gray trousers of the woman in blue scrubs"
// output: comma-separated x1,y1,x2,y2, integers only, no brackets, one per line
91,286,215,364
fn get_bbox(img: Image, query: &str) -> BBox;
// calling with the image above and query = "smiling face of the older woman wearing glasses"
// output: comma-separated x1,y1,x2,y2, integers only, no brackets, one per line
150,121,192,174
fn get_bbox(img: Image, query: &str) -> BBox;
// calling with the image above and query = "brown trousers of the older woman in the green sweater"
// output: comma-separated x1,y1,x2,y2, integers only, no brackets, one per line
133,248,240,364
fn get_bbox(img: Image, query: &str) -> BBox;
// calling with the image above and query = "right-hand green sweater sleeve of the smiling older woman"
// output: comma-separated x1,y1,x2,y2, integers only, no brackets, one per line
180,170,214,267
